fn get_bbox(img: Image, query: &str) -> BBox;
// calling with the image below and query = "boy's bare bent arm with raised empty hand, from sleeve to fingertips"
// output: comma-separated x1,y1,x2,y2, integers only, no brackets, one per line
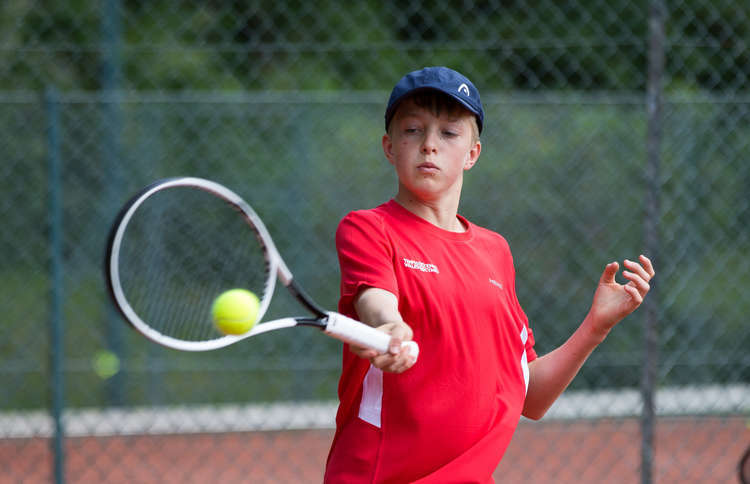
523,255,655,420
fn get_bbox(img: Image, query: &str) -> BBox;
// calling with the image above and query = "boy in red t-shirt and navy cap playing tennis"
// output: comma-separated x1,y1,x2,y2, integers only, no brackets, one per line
325,67,654,484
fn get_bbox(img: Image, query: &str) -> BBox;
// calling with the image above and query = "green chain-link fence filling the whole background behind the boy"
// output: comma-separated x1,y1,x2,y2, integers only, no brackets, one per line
0,0,750,483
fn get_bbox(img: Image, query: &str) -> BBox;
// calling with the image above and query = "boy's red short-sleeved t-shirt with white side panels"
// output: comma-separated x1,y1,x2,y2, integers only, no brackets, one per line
325,200,536,484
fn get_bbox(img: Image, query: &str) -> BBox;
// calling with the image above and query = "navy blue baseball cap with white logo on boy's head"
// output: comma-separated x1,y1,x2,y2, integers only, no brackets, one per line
385,67,484,133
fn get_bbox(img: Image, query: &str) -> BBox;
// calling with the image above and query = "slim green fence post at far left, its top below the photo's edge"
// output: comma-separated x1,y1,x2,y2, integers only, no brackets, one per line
44,87,65,484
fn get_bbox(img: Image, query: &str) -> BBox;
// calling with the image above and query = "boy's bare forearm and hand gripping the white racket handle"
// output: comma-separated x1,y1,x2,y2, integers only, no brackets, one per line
349,287,415,373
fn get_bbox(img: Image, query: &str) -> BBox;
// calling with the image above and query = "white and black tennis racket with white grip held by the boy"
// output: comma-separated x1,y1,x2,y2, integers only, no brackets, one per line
105,177,419,358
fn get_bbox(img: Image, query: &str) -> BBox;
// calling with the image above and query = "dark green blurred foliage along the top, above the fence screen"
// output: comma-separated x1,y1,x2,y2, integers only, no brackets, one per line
0,0,750,91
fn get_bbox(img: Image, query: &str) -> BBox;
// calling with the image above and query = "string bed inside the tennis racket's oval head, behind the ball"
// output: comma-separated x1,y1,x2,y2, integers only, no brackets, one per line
118,187,270,341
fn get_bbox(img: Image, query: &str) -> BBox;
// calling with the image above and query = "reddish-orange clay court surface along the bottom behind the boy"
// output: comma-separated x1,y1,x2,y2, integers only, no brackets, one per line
0,416,750,484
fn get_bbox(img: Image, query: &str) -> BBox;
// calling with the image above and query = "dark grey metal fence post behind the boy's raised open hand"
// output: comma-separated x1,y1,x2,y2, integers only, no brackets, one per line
641,0,665,484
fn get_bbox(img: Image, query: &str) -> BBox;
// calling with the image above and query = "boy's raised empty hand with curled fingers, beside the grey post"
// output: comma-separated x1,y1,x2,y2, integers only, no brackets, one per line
586,255,656,338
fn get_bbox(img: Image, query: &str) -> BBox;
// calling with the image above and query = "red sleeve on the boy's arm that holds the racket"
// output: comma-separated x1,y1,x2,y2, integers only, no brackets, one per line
336,211,398,314
